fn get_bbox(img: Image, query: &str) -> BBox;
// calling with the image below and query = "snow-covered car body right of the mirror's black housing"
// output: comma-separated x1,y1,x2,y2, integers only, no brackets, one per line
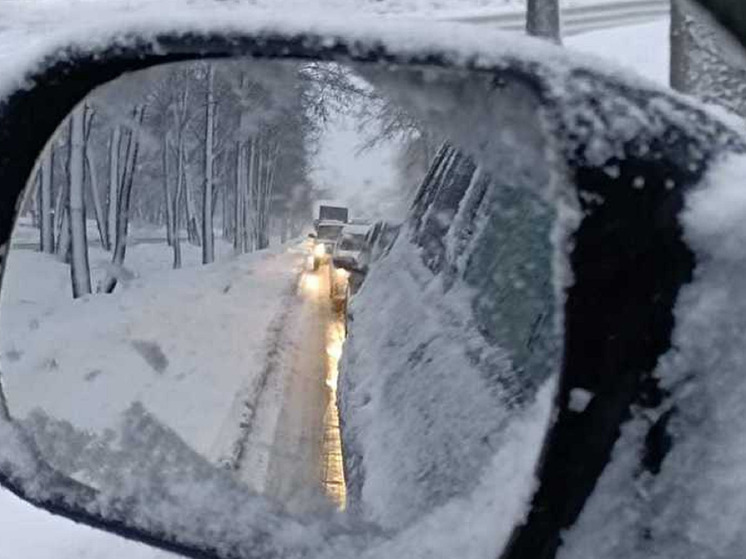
559,155,746,559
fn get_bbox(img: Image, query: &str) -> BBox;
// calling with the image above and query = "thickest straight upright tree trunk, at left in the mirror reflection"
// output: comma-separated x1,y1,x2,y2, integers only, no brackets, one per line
68,106,91,299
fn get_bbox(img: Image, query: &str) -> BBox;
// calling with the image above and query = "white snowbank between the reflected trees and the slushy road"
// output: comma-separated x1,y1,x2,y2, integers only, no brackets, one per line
0,245,304,459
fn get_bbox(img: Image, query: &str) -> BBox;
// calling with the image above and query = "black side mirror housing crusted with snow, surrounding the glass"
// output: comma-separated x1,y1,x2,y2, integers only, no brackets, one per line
0,6,744,559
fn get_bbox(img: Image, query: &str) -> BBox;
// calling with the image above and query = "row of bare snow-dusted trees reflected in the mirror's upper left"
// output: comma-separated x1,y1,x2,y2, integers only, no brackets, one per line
27,60,316,297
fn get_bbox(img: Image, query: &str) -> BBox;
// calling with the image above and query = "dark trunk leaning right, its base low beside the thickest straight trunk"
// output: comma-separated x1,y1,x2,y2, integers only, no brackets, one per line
99,105,145,293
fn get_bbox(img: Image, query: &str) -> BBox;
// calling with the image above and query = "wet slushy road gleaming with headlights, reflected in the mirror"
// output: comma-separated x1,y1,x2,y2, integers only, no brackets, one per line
217,254,344,509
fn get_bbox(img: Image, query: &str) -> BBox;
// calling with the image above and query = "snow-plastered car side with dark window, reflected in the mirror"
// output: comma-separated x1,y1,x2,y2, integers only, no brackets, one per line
340,129,559,541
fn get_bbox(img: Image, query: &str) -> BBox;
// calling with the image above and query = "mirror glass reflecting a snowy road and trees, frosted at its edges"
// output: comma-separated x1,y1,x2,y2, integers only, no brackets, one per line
0,59,561,557
